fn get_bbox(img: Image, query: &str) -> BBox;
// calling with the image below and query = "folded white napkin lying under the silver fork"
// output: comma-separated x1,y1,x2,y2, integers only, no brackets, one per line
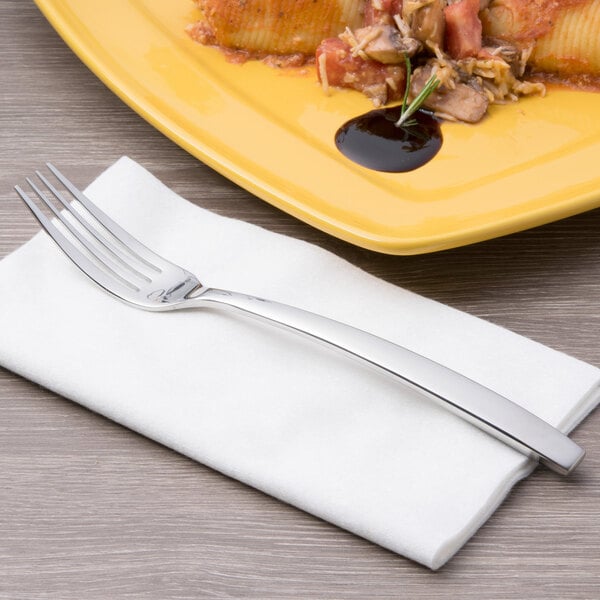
0,158,600,569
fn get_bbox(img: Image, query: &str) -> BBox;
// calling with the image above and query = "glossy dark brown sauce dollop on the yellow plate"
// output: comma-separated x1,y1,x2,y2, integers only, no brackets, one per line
335,106,442,173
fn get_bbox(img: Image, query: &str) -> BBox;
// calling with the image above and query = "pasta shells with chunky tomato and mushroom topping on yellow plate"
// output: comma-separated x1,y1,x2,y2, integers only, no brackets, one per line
189,0,600,123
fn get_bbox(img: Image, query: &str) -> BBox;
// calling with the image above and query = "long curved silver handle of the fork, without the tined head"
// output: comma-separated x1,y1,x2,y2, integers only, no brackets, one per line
190,288,585,475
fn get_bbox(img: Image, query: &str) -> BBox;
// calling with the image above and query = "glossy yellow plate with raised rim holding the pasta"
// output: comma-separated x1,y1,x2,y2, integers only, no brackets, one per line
37,0,600,254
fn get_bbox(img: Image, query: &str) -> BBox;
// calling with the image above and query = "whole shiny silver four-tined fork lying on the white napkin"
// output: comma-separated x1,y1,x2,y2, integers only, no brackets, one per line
15,163,585,475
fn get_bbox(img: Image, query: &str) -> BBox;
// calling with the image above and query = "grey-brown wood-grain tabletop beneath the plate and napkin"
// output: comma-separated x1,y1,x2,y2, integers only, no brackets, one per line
0,0,600,600
